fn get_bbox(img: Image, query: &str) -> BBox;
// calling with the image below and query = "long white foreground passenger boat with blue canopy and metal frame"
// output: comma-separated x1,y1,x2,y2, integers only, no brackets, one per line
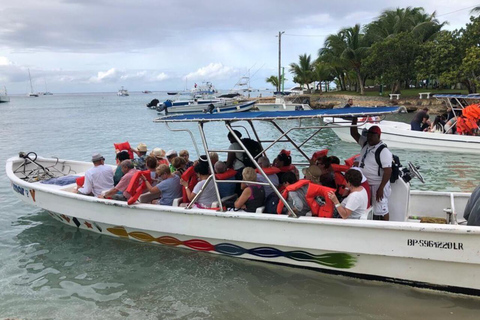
6,107,480,295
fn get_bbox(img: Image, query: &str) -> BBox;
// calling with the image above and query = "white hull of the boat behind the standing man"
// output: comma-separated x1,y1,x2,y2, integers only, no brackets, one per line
327,121,480,154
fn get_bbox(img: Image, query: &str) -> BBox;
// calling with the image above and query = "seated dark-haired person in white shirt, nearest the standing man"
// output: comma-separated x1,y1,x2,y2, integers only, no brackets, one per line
328,169,368,219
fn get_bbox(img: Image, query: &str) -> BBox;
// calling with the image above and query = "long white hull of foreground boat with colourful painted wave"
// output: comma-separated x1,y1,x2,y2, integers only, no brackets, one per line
6,158,480,294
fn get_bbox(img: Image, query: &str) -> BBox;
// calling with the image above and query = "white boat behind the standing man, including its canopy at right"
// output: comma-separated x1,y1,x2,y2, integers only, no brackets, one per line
323,95,480,154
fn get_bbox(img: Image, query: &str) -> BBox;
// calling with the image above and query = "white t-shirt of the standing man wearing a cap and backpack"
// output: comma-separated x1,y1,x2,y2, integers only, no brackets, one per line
358,136,393,186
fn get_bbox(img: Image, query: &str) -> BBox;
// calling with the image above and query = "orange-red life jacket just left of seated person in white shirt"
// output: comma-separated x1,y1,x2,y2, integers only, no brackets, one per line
277,180,335,218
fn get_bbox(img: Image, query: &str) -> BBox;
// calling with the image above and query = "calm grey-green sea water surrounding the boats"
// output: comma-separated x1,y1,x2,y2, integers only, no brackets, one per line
0,93,480,319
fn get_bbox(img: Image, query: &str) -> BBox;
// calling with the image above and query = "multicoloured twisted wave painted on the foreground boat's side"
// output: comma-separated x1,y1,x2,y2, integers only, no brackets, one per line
107,226,356,269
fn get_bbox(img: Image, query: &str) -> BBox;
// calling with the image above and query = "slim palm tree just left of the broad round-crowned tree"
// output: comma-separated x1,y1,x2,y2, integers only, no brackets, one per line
341,24,368,95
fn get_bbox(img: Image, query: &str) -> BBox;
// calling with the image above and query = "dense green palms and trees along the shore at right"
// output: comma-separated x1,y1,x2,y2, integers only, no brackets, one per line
266,7,480,95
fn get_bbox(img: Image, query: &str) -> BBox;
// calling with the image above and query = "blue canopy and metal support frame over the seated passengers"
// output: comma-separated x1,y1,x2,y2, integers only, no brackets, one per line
154,107,401,218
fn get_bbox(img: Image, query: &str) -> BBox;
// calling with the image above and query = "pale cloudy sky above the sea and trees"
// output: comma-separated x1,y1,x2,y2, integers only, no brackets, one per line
0,0,480,94
